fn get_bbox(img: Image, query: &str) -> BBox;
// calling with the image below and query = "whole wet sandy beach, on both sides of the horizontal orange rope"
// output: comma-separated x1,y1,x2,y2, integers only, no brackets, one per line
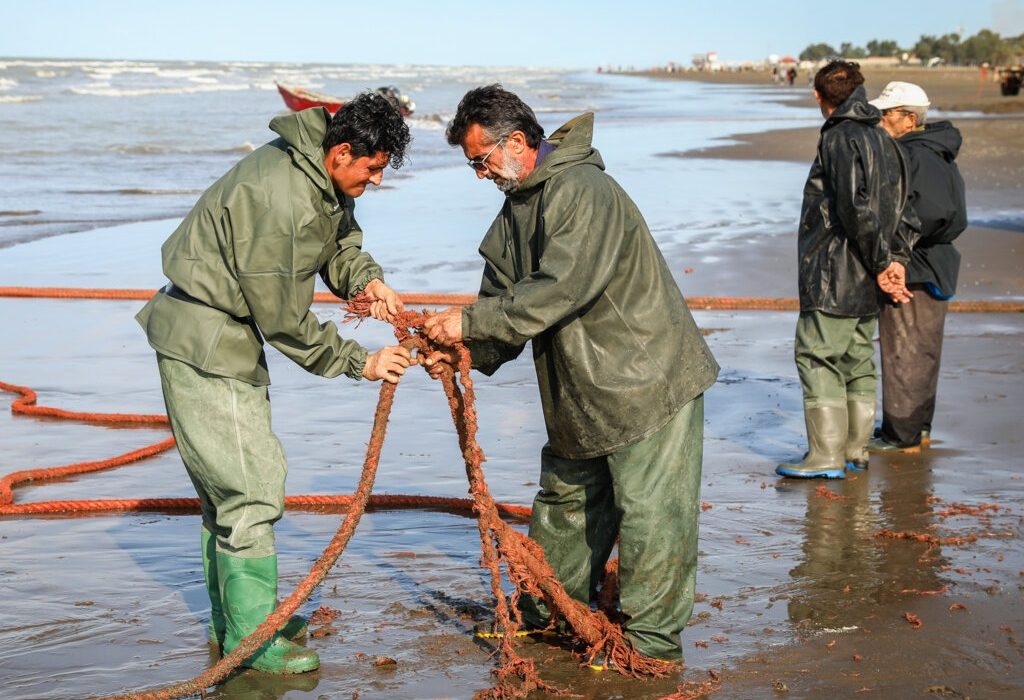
0,62,1024,700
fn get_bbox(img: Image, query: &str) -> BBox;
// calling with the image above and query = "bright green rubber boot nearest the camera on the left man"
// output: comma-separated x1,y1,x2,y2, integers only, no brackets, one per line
216,552,319,673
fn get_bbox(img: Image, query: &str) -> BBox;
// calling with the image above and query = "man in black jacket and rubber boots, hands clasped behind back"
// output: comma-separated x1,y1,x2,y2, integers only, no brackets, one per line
775,60,912,479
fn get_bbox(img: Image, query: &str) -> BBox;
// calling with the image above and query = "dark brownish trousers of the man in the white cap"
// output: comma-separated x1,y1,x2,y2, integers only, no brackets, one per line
879,288,949,447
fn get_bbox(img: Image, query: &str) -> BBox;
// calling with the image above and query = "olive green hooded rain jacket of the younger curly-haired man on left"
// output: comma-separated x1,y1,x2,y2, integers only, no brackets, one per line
136,108,383,386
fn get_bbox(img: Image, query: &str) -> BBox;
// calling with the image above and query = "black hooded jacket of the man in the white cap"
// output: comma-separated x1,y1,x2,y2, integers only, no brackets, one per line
896,122,967,299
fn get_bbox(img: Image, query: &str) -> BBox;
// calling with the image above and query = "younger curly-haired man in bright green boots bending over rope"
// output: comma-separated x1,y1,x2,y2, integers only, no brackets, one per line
136,93,411,673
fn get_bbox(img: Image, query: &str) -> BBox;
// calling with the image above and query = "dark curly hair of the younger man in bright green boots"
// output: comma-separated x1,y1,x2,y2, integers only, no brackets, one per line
324,92,413,170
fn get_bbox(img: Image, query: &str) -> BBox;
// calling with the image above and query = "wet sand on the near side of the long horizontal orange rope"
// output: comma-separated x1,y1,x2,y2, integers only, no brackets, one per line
0,300,1024,699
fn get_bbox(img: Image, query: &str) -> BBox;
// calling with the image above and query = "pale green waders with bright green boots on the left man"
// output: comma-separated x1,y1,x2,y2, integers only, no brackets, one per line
157,354,318,673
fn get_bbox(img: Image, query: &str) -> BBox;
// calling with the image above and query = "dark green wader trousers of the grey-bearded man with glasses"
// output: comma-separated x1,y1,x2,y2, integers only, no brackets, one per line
521,395,703,660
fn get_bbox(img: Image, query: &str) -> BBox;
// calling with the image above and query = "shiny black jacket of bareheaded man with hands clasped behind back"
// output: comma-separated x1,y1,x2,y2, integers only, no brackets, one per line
797,87,913,316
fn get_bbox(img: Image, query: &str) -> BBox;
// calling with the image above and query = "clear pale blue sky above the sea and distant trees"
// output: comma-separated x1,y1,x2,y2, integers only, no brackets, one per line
0,0,1024,68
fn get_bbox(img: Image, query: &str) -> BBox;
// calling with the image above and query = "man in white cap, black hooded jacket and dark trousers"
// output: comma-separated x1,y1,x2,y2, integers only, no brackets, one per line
867,82,967,452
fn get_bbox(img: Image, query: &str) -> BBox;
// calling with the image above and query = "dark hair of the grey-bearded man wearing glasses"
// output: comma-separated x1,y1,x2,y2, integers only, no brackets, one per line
445,83,544,148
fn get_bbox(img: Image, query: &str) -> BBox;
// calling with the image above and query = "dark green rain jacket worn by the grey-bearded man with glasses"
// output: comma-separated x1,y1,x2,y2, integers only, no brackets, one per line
462,114,719,460
